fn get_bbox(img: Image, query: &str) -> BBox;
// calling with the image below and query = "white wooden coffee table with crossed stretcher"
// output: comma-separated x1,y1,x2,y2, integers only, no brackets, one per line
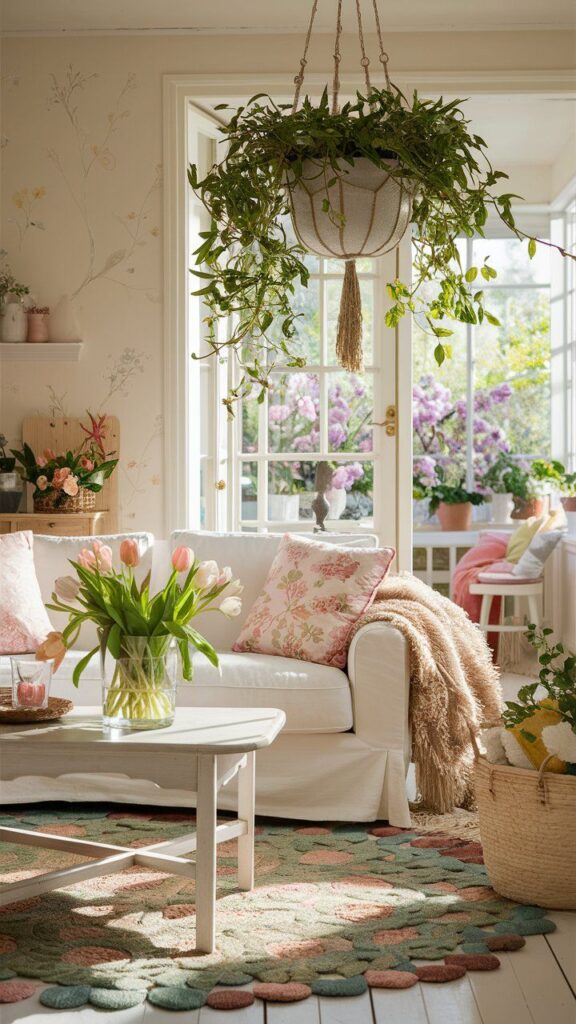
0,708,286,952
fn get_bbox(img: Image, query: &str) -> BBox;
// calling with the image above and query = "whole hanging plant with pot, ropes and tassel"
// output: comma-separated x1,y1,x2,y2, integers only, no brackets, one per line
189,0,574,411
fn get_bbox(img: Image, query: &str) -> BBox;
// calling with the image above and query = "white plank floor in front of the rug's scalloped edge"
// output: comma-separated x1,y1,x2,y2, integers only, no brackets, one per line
0,674,576,1024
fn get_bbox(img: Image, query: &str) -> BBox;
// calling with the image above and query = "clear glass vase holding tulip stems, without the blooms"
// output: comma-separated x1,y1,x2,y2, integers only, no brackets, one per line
100,636,177,729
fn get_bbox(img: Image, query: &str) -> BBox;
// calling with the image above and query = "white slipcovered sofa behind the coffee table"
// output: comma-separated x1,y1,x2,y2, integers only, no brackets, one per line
0,531,410,826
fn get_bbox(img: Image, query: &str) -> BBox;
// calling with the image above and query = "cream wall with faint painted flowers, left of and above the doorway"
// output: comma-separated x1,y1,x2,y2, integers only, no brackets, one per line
0,32,574,535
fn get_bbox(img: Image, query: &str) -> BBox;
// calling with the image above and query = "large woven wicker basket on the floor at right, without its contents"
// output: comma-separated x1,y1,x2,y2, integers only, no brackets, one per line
475,757,576,910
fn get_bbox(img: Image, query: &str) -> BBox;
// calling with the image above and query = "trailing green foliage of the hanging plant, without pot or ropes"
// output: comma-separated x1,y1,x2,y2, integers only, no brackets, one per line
189,86,574,411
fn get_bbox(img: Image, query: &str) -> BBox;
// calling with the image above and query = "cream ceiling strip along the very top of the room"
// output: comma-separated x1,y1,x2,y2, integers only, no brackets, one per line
0,0,576,34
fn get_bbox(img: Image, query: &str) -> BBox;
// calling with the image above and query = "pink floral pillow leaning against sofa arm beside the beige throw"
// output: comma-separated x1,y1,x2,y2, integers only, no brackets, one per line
233,534,395,669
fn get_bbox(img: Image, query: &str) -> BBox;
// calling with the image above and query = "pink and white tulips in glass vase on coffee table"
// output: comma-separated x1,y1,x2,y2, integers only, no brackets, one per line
37,539,243,727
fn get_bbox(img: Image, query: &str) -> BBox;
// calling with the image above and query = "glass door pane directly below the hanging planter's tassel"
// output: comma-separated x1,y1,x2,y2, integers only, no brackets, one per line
328,373,374,452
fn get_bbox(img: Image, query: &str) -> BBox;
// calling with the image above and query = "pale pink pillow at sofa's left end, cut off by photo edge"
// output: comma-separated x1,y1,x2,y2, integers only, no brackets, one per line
0,530,52,654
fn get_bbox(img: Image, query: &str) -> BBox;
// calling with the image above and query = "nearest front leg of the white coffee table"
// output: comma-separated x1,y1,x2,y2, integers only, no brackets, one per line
196,754,217,953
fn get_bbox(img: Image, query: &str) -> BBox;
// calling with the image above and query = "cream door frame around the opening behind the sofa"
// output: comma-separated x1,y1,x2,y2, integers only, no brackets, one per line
163,71,576,569
